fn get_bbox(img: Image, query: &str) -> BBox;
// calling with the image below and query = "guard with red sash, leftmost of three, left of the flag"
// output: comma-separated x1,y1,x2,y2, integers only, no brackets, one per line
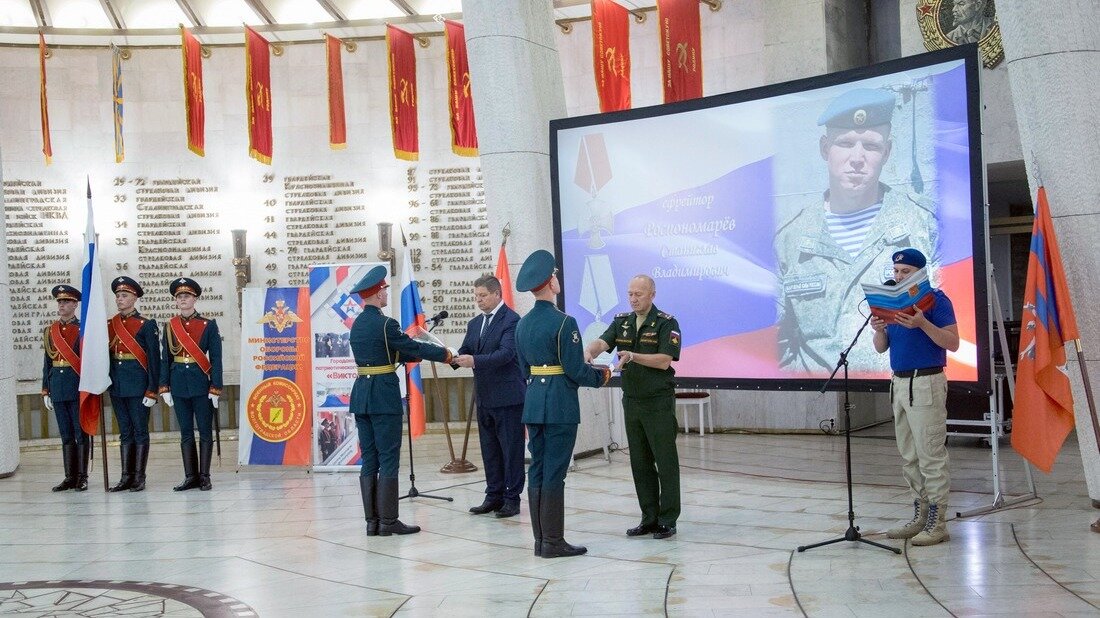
42,285,91,492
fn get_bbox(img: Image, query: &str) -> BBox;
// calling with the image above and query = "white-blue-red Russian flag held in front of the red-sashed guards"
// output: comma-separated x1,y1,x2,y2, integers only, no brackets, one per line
79,179,111,435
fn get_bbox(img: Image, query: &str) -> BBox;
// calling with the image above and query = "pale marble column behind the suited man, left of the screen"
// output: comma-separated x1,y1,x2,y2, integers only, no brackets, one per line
462,0,609,452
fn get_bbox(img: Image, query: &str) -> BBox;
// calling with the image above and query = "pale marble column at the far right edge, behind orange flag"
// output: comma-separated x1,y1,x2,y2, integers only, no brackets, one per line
997,0,1100,500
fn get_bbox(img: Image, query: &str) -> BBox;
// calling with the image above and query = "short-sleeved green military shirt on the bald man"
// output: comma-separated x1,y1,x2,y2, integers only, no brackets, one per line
600,305,680,398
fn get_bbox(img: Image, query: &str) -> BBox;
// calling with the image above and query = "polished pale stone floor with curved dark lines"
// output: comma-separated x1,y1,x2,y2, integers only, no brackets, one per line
0,431,1100,617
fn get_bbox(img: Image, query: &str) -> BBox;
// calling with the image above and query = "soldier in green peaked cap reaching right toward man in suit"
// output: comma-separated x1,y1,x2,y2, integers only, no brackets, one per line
349,266,452,537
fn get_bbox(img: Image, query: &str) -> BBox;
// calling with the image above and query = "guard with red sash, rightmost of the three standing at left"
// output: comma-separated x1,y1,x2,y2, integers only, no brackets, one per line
160,277,222,492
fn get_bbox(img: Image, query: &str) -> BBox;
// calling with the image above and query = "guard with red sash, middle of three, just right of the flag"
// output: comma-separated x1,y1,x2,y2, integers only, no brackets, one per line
107,276,161,492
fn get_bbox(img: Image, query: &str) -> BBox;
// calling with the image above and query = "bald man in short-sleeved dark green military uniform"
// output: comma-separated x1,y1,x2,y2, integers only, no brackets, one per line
585,275,680,539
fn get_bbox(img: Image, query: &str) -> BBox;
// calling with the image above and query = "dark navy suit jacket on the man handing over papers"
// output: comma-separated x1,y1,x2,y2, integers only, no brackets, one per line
459,305,527,408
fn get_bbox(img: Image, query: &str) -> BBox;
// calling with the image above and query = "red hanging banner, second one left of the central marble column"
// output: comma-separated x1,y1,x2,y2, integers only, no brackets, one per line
386,25,420,161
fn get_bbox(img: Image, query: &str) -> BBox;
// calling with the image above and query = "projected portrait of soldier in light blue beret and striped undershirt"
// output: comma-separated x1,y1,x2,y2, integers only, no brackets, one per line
774,88,938,373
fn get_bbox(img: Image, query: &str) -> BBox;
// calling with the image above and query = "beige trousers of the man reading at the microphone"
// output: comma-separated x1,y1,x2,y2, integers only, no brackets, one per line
890,373,950,503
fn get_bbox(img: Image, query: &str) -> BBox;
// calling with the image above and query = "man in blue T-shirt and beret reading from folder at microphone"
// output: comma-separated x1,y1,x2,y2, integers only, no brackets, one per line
871,247,959,545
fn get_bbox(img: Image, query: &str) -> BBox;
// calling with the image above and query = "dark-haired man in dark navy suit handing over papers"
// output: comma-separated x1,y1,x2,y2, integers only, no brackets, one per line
454,275,527,517
